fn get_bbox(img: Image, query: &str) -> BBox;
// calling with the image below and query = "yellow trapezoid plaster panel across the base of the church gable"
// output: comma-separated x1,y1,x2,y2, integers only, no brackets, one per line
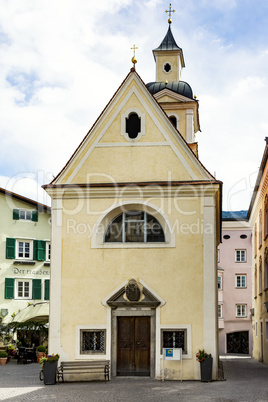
74,146,195,183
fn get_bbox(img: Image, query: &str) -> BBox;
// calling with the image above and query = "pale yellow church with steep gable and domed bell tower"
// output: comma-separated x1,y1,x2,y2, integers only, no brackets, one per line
44,20,222,380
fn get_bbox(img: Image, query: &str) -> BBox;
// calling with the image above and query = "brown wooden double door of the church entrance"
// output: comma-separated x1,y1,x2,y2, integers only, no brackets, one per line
117,317,151,376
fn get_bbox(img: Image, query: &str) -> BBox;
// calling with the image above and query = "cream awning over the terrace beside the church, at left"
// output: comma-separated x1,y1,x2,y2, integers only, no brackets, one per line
2,302,49,324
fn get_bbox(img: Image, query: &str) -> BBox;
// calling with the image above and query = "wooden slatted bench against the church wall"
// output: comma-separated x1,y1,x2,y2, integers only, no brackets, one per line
57,360,110,383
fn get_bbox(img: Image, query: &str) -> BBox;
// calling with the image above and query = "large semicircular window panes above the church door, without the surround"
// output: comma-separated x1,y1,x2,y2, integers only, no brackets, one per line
104,211,165,243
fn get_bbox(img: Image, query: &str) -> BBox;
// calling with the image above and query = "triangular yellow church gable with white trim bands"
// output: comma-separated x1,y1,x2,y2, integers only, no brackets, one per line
52,71,213,185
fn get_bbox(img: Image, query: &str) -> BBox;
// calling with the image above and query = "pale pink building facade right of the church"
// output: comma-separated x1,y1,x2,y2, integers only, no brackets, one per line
218,215,252,355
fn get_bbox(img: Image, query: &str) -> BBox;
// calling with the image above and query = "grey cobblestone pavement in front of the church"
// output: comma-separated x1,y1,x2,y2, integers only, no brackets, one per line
0,358,268,402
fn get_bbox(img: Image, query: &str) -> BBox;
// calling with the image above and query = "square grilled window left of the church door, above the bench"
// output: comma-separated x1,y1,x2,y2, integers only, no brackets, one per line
80,329,106,354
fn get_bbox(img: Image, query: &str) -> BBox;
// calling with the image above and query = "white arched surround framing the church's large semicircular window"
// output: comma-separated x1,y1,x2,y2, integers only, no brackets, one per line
91,200,175,248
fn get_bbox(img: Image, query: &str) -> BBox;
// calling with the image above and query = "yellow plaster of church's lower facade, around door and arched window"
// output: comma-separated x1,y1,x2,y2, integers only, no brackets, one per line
61,197,203,373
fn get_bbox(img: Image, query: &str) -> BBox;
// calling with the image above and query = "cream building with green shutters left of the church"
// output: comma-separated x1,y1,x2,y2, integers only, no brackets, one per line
0,187,51,323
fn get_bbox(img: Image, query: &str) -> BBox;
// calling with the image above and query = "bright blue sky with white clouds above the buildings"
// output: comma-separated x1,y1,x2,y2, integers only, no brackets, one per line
0,0,268,211
